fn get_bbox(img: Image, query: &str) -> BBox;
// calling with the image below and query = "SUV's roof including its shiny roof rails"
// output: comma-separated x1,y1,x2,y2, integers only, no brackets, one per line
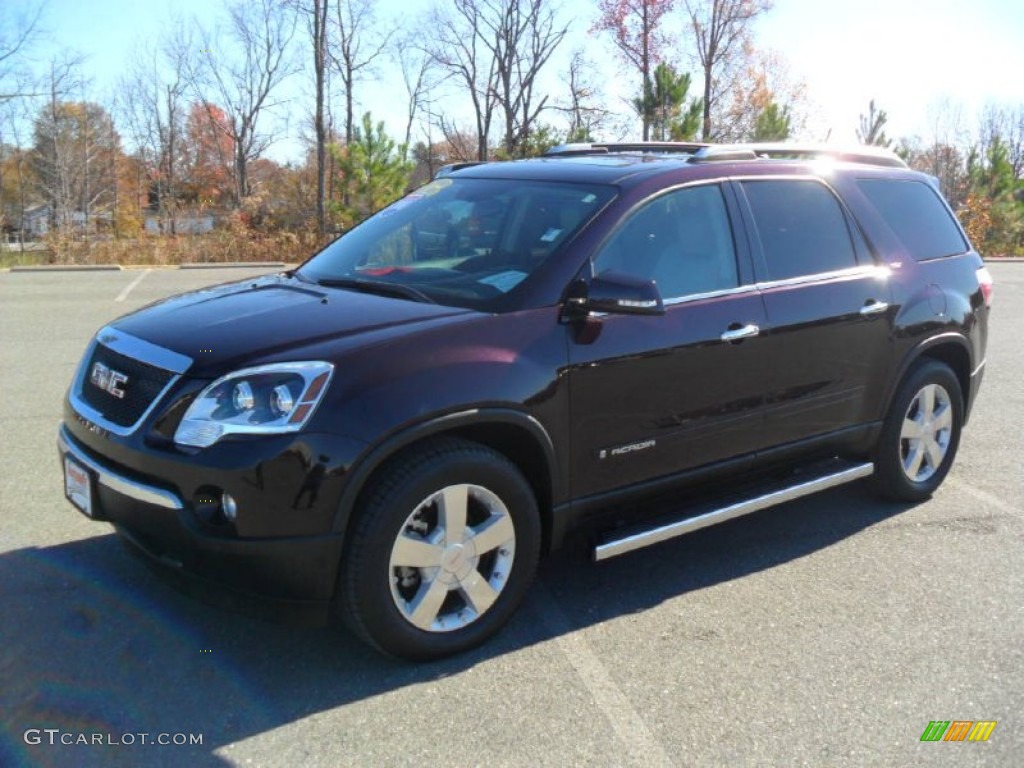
451,141,907,184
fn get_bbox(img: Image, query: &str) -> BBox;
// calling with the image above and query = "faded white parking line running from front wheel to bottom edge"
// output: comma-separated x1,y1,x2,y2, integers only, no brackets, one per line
534,582,674,768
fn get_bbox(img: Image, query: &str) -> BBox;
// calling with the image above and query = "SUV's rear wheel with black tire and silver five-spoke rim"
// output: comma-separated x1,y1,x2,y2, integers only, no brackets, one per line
872,359,964,502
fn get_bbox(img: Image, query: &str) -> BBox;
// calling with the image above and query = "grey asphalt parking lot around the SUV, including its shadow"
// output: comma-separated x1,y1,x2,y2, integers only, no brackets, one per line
0,264,1024,766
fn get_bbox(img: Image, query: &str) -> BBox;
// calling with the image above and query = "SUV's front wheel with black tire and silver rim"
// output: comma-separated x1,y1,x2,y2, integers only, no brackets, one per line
336,438,541,660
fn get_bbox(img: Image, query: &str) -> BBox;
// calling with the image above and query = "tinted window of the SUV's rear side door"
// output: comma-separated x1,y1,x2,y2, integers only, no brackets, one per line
743,180,857,280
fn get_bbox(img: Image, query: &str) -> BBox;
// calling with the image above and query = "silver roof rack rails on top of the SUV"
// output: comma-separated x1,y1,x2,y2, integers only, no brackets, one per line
544,141,907,168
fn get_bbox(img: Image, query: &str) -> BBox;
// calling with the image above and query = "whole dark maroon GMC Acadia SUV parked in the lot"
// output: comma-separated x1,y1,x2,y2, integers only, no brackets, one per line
58,143,992,658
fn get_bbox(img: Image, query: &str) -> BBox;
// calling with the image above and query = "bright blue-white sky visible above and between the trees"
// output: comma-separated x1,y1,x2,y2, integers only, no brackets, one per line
9,0,1024,160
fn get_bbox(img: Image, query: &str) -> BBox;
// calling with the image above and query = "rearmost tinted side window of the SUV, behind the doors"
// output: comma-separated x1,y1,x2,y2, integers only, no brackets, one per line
857,179,968,261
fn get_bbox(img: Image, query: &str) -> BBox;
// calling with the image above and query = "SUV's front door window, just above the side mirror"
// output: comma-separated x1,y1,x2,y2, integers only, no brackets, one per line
594,184,738,299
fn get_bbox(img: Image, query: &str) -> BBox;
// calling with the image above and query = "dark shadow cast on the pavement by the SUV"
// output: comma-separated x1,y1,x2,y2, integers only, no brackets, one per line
0,484,907,766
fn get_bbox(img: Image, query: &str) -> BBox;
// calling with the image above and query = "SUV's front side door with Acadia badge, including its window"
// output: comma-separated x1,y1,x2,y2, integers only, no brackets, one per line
568,183,768,498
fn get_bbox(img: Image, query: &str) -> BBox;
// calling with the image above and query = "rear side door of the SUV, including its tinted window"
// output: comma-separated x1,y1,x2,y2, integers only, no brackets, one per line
737,177,892,445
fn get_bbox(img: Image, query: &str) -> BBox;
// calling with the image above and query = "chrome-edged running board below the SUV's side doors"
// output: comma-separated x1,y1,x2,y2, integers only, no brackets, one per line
594,462,874,560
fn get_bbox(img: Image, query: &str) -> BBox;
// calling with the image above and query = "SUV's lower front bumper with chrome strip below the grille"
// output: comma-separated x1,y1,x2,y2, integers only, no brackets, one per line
57,424,342,614
